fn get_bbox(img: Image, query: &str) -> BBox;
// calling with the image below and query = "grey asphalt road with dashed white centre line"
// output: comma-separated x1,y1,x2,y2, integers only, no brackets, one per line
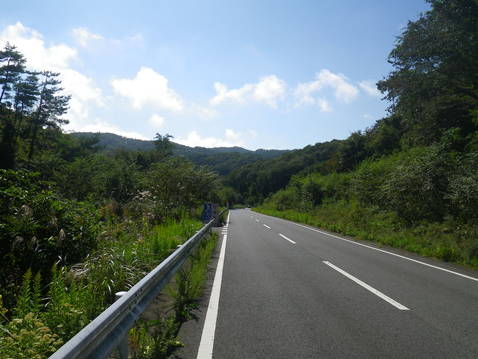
176,210,478,359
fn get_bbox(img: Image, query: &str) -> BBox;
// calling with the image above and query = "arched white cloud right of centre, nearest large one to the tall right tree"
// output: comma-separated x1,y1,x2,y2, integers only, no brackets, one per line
294,69,358,111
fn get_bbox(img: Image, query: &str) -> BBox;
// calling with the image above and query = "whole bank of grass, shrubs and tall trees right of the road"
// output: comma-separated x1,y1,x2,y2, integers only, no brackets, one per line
257,0,478,269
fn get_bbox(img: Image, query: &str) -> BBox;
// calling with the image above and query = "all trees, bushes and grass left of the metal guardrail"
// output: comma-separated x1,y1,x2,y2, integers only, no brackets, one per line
0,43,228,359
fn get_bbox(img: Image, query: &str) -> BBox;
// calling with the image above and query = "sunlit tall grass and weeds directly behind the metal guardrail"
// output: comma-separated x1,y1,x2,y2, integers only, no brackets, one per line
0,212,207,358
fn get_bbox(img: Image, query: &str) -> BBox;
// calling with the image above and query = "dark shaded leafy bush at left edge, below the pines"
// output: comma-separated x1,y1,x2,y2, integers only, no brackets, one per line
0,170,99,305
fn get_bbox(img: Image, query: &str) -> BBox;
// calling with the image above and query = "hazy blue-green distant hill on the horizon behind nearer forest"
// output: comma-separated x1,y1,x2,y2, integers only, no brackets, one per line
71,132,292,176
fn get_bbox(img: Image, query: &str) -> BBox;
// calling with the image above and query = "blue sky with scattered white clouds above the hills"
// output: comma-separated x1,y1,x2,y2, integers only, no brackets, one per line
0,0,429,150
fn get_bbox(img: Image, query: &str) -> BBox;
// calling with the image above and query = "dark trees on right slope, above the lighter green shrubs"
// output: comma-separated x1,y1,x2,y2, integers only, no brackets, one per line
336,0,478,172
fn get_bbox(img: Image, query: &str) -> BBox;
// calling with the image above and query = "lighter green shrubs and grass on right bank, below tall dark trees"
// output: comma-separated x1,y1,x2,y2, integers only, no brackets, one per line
260,143,478,268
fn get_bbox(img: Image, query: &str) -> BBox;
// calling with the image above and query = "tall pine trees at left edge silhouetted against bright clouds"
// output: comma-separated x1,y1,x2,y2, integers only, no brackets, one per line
0,42,70,169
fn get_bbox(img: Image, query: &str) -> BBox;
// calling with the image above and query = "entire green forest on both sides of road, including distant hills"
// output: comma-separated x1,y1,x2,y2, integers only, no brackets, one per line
0,0,478,353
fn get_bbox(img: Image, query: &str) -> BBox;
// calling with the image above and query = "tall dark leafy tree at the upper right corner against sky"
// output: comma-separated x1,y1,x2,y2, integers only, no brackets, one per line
378,0,478,145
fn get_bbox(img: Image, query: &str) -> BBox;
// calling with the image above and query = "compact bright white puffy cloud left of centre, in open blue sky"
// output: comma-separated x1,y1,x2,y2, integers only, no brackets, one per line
111,66,184,111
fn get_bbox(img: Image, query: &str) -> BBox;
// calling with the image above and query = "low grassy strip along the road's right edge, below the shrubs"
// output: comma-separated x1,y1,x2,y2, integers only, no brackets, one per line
254,200,478,269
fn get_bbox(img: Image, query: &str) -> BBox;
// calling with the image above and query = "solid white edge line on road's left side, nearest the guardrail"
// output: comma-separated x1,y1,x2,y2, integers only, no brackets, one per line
197,213,231,359
